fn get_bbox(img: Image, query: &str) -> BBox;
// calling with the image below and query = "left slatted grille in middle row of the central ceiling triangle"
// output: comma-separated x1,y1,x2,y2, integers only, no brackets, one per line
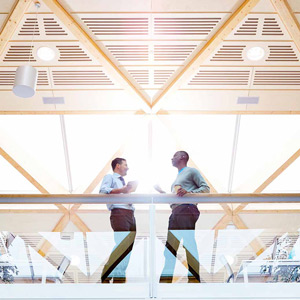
106,45,149,62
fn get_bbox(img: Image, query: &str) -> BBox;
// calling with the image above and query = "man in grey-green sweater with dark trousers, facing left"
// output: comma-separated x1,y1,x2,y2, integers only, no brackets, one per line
157,151,210,283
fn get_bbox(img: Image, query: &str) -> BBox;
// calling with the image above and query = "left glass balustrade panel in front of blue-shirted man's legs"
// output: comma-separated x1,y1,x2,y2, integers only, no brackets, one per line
0,204,150,298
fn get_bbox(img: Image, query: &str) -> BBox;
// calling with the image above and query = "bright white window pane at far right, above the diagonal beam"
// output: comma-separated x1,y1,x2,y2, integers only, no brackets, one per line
233,115,300,193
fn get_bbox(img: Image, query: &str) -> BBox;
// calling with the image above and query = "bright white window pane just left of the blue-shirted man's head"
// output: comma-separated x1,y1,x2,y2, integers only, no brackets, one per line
65,115,145,193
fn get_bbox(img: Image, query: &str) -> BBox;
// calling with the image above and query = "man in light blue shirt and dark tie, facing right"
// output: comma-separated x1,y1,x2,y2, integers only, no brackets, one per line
100,157,136,283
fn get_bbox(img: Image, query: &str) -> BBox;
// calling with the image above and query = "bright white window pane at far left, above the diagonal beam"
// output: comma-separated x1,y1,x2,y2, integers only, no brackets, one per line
0,115,68,193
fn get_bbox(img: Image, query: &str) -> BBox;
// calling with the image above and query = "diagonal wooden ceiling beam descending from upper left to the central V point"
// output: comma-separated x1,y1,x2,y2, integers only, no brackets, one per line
43,0,151,112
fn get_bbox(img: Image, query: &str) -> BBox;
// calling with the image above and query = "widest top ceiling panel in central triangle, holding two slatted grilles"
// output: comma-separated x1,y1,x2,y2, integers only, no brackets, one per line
76,13,227,41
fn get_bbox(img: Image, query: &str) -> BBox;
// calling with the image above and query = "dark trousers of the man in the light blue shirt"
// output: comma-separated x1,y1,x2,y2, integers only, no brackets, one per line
101,208,136,283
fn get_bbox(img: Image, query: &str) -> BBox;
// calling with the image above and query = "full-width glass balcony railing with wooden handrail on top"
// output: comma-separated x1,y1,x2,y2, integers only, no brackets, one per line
0,194,300,299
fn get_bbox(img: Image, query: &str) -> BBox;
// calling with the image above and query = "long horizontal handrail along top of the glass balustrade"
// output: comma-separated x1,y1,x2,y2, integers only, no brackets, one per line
0,193,300,204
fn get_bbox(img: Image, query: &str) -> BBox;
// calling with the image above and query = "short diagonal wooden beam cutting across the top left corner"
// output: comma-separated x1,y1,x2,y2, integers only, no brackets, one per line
0,0,32,56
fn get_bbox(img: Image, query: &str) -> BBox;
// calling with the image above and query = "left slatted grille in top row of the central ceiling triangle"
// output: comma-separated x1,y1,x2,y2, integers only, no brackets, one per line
82,18,149,35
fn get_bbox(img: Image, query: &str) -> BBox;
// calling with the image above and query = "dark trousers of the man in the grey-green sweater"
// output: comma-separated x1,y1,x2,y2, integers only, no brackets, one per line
160,204,200,283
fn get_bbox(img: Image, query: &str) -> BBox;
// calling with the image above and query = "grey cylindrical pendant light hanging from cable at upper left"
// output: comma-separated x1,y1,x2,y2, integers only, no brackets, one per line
13,2,41,98
